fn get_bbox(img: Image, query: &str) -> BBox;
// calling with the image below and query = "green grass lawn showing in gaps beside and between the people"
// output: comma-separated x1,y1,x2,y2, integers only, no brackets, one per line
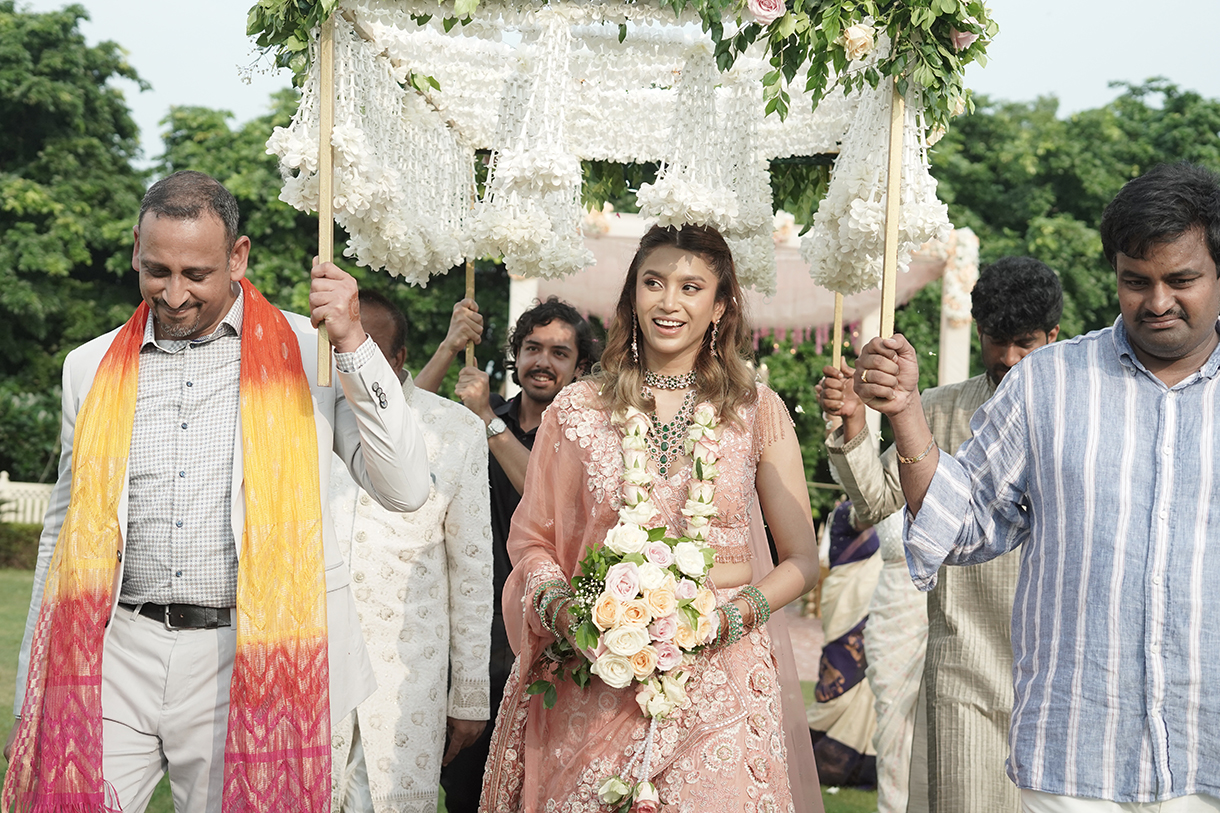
0,570,877,813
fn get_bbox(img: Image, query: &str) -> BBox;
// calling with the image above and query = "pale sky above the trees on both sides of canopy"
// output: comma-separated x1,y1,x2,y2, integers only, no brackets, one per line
18,0,1220,161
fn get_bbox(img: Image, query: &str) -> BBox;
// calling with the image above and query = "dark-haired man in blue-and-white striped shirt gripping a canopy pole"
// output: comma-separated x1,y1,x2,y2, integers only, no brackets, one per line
855,165,1220,813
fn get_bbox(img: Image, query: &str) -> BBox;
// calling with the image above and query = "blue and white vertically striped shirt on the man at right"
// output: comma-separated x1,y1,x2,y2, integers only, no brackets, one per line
906,319,1220,802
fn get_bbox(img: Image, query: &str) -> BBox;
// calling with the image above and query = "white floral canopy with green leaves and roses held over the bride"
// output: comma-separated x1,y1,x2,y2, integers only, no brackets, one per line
250,0,993,292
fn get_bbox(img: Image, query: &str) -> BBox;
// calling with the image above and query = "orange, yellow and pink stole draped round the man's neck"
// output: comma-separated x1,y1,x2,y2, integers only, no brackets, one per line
0,280,331,813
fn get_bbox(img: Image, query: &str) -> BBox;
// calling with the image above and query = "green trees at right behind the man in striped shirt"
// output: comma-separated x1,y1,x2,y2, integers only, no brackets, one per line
932,79,1220,337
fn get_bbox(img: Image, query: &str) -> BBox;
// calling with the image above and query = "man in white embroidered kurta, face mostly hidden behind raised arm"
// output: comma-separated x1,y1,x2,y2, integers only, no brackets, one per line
331,292,492,813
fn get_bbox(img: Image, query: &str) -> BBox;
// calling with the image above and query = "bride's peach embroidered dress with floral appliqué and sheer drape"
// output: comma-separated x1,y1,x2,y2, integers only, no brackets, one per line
481,382,821,813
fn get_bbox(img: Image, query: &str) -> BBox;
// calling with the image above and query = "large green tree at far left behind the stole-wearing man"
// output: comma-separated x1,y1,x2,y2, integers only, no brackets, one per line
0,0,145,480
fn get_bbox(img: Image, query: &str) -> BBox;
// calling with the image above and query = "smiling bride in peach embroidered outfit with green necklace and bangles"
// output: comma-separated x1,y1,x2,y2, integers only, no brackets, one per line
481,226,822,813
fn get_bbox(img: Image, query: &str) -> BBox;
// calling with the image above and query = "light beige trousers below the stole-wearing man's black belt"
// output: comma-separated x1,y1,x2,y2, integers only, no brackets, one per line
101,600,237,813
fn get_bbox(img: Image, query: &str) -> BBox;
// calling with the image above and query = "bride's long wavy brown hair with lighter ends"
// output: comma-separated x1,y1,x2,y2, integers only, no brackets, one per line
593,226,758,422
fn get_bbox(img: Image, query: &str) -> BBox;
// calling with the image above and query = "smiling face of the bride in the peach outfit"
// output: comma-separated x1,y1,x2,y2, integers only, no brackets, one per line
636,245,725,374
